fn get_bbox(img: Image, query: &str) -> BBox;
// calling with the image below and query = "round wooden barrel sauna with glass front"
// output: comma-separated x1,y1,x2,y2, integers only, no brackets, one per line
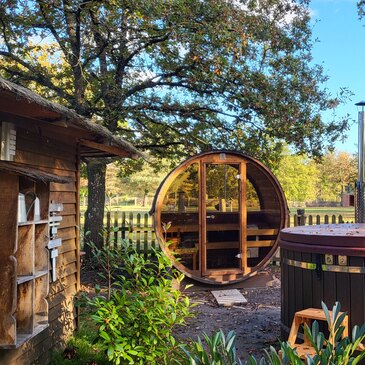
152,151,288,284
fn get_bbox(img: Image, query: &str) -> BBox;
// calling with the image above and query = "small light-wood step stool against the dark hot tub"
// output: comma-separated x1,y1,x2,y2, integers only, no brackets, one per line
288,308,349,359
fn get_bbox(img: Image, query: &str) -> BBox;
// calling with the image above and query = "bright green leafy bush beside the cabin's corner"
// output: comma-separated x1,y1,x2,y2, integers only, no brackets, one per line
78,242,191,365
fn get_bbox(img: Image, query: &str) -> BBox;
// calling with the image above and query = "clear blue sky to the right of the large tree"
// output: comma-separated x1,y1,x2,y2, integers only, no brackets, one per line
310,0,365,153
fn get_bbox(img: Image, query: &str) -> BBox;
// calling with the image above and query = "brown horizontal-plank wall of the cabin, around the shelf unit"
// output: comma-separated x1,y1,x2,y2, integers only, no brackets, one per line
0,121,80,365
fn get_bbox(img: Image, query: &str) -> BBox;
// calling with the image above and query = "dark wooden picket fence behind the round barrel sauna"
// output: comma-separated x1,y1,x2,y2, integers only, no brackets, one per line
91,212,354,253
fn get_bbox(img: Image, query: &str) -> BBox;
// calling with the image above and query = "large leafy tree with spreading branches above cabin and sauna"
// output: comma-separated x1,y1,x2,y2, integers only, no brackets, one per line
0,0,347,249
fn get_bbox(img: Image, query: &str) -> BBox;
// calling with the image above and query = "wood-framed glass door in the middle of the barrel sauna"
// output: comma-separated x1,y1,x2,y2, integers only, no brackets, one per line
202,163,242,275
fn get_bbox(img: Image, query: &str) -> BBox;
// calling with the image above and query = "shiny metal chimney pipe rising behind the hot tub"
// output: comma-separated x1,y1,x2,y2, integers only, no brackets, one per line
355,101,365,223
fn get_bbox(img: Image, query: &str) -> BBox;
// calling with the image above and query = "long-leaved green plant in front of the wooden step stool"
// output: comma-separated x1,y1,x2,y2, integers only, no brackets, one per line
248,302,365,365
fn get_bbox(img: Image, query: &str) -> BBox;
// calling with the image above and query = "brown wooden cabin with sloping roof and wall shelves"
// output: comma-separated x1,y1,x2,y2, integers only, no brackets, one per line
0,78,139,365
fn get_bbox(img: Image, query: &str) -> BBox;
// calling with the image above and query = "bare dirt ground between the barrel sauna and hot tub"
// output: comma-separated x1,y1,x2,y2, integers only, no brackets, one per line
176,268,280,362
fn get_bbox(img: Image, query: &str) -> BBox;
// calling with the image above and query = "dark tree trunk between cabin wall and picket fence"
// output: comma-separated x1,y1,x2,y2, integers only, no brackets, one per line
84,160,106,258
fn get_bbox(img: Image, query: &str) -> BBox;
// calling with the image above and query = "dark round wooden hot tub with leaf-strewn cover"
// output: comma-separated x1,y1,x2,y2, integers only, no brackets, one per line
280,224,365,339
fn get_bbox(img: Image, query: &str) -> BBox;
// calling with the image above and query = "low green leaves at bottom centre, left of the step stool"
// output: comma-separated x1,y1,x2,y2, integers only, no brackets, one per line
175,330,242,365
